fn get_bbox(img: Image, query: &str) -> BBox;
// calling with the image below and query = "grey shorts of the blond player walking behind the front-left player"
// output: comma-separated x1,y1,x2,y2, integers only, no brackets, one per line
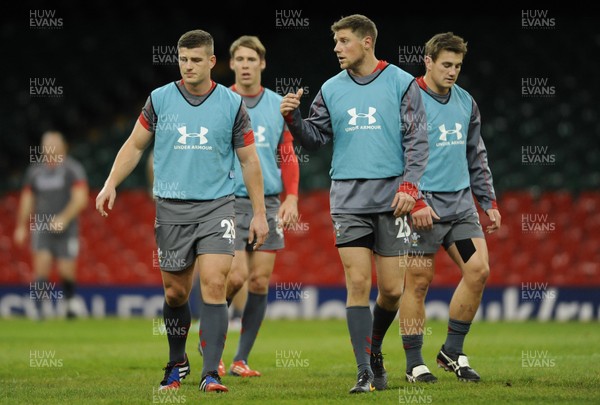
235,196,285,251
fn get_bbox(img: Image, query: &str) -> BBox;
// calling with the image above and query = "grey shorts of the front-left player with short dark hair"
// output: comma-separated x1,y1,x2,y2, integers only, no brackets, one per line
154,196,235,271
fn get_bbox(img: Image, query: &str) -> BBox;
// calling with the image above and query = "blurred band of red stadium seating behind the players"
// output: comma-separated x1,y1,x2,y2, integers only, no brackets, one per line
0,190,600,287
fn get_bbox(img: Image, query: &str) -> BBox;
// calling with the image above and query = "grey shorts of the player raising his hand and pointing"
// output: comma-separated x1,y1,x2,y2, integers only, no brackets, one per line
331,212,402,256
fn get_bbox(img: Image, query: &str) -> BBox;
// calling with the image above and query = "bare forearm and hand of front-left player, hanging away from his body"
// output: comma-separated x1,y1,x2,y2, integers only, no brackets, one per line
96,120,153,217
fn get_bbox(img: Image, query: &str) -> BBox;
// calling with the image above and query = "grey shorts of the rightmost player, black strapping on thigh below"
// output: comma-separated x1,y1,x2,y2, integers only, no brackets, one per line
401,212,485,254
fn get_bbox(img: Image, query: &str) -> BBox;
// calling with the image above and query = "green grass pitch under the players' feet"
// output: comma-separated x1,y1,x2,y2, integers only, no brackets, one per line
0,318,600,405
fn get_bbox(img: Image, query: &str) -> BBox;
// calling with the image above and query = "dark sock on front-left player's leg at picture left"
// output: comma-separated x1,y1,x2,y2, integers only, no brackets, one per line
163,301,192,362
